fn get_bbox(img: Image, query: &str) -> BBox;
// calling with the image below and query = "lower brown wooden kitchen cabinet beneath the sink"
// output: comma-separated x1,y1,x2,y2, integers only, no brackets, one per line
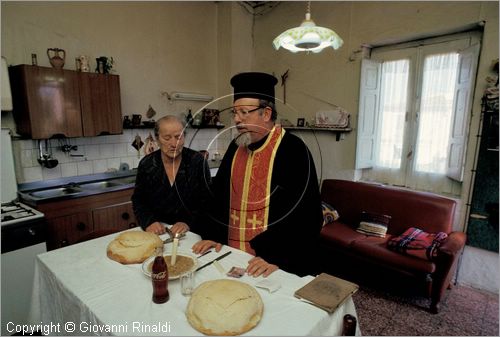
35,188,137,250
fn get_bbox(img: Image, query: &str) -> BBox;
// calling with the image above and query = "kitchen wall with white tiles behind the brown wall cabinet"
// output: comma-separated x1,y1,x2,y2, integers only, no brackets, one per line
1,1,231,183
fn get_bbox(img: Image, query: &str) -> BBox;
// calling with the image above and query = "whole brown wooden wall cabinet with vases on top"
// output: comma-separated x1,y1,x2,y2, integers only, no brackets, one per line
9,65,122,139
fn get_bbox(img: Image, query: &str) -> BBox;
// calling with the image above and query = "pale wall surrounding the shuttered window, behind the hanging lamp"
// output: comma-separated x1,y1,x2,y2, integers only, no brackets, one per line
254,1,500,293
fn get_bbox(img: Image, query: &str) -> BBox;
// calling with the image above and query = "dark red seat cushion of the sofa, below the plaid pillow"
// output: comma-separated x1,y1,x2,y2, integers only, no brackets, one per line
350,235,436,273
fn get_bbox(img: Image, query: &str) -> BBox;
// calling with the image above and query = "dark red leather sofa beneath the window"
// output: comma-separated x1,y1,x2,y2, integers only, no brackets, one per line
320,180,466,313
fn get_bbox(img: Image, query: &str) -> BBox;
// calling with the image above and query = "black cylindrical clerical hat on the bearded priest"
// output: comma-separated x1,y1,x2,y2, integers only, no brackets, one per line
231,72,278,103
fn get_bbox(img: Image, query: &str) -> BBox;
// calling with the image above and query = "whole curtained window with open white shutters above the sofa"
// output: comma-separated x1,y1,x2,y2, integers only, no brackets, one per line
356,33,480,194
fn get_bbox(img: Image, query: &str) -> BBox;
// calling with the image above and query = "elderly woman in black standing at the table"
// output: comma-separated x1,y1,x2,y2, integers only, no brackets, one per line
132,116,211,234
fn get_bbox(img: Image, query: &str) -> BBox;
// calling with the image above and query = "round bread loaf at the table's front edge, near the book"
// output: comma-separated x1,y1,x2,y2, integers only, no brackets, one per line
186,280,264,336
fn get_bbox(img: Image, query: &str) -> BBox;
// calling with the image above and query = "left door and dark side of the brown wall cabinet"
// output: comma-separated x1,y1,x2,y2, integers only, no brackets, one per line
9,65,83,139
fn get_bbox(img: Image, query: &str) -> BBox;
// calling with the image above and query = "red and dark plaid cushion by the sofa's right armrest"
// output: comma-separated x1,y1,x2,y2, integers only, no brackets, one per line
387,227,448,260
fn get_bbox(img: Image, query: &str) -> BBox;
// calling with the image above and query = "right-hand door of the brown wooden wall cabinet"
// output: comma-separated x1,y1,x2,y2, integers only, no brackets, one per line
78,73,122,137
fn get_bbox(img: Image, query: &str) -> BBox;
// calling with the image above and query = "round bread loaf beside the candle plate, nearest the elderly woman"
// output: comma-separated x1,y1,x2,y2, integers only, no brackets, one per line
106,231,163,264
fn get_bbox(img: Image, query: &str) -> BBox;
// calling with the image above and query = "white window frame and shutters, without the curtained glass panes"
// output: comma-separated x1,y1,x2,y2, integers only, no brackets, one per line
355,31,482,194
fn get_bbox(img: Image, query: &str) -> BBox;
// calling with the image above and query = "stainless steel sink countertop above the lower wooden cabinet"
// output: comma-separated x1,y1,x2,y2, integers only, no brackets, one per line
17,169,137,206
